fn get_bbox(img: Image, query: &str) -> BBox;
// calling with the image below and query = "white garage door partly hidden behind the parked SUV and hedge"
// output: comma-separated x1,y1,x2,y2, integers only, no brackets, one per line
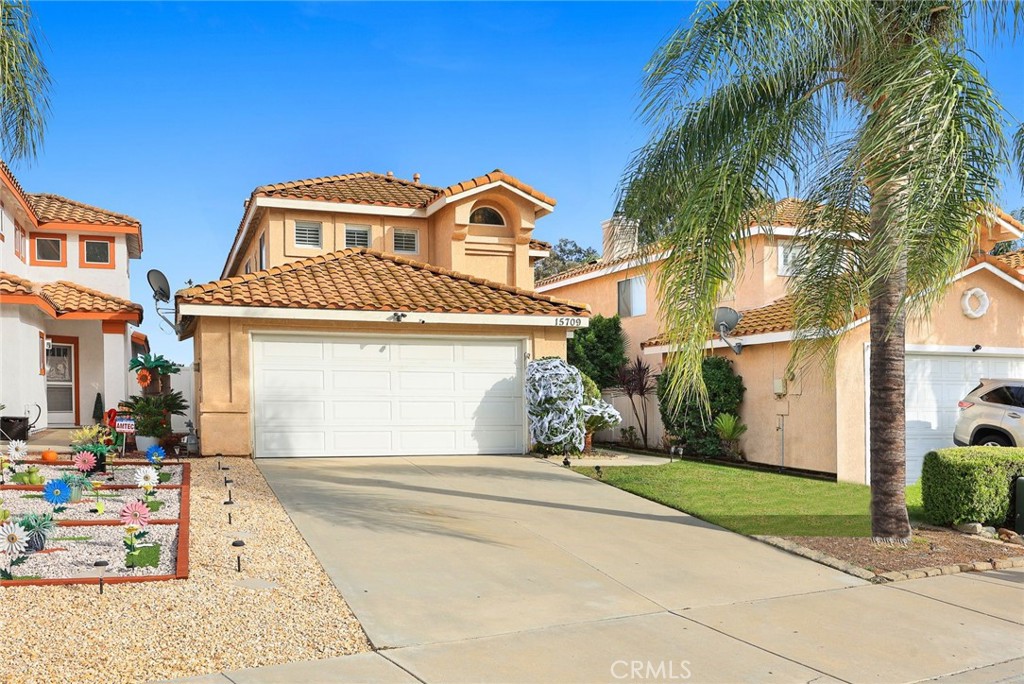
906,352,1024,483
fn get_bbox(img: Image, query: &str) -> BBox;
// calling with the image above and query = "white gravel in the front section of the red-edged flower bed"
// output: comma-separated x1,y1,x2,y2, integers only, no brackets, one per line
13,525,178,591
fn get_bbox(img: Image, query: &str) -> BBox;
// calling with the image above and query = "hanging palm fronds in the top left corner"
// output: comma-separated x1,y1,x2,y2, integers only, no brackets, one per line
0,0,50,160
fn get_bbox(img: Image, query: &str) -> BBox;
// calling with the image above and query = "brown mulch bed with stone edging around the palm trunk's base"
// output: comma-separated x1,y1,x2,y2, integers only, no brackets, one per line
784,529,1024,572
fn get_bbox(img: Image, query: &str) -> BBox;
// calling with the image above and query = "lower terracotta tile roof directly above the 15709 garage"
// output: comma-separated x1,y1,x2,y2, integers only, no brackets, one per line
182,249,590,316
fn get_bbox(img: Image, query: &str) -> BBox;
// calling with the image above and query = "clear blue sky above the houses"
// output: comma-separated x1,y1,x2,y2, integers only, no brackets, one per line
14,2,1024,361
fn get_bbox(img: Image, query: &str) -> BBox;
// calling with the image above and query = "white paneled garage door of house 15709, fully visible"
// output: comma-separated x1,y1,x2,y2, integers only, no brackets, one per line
253,335,525,457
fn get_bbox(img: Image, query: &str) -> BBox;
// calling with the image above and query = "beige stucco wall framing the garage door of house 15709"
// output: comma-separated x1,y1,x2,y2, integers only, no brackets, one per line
194,316,566,456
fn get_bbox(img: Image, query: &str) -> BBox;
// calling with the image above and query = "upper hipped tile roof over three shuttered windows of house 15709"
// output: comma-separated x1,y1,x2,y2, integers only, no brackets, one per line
252,172,441,207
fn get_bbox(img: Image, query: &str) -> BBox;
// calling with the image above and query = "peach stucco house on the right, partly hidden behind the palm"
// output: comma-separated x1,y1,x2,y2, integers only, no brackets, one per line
538,199,1024,482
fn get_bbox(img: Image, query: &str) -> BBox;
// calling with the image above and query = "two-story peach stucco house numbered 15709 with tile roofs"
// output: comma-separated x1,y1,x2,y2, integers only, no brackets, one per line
175,171,589,457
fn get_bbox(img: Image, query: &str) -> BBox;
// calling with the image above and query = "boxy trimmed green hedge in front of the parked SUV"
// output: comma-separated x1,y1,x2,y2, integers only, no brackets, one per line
921,446,1024,525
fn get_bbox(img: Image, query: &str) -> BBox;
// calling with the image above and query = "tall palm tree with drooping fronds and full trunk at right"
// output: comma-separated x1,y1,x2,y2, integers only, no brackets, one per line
621,0,1024,543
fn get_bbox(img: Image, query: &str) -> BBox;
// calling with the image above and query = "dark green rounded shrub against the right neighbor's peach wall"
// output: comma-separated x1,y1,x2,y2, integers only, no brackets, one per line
657,356,745,458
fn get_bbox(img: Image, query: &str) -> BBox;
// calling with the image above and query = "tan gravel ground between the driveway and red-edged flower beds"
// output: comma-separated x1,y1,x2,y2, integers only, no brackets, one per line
0,459,370,684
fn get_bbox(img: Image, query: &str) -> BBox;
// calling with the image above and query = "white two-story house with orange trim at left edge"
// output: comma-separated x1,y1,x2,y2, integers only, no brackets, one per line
0,162,145,429
